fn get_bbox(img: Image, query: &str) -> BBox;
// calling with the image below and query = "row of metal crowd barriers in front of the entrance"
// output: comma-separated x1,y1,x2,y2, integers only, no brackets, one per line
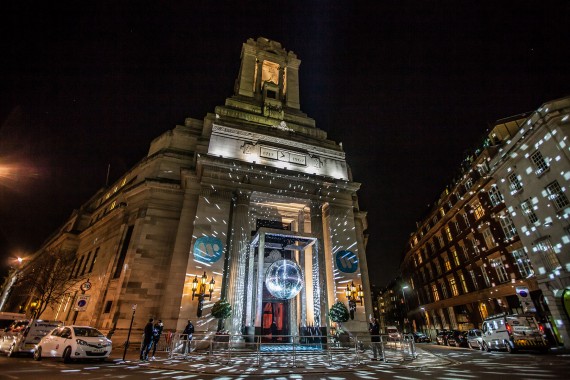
165,333,417,367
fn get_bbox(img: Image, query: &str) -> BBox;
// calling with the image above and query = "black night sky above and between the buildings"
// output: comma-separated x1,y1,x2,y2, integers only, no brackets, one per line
0,0,570,285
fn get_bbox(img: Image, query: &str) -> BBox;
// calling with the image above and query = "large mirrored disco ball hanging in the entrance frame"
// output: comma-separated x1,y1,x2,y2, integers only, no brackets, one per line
265,259,303,300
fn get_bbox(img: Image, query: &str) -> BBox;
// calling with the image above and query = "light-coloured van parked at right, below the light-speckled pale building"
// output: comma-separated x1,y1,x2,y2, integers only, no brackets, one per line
481,313,549,353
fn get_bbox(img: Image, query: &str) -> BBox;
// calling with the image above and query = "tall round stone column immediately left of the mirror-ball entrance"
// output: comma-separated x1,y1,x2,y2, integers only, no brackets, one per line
228,191,251,334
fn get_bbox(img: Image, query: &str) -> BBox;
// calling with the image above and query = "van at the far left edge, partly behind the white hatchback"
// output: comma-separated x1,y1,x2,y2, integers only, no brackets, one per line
0,319,63,357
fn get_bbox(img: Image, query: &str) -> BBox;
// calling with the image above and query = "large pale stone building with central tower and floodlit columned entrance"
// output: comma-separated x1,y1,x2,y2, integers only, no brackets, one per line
3,38,372,342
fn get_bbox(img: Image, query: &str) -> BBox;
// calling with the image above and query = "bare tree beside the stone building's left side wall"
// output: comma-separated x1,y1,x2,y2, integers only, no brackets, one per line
18,251,84,318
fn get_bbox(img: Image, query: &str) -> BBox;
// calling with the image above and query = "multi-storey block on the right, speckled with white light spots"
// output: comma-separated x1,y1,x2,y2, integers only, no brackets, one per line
400,98,570,345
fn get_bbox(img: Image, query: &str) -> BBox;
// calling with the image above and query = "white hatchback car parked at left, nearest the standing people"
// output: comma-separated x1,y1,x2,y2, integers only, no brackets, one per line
34,326,112,363
